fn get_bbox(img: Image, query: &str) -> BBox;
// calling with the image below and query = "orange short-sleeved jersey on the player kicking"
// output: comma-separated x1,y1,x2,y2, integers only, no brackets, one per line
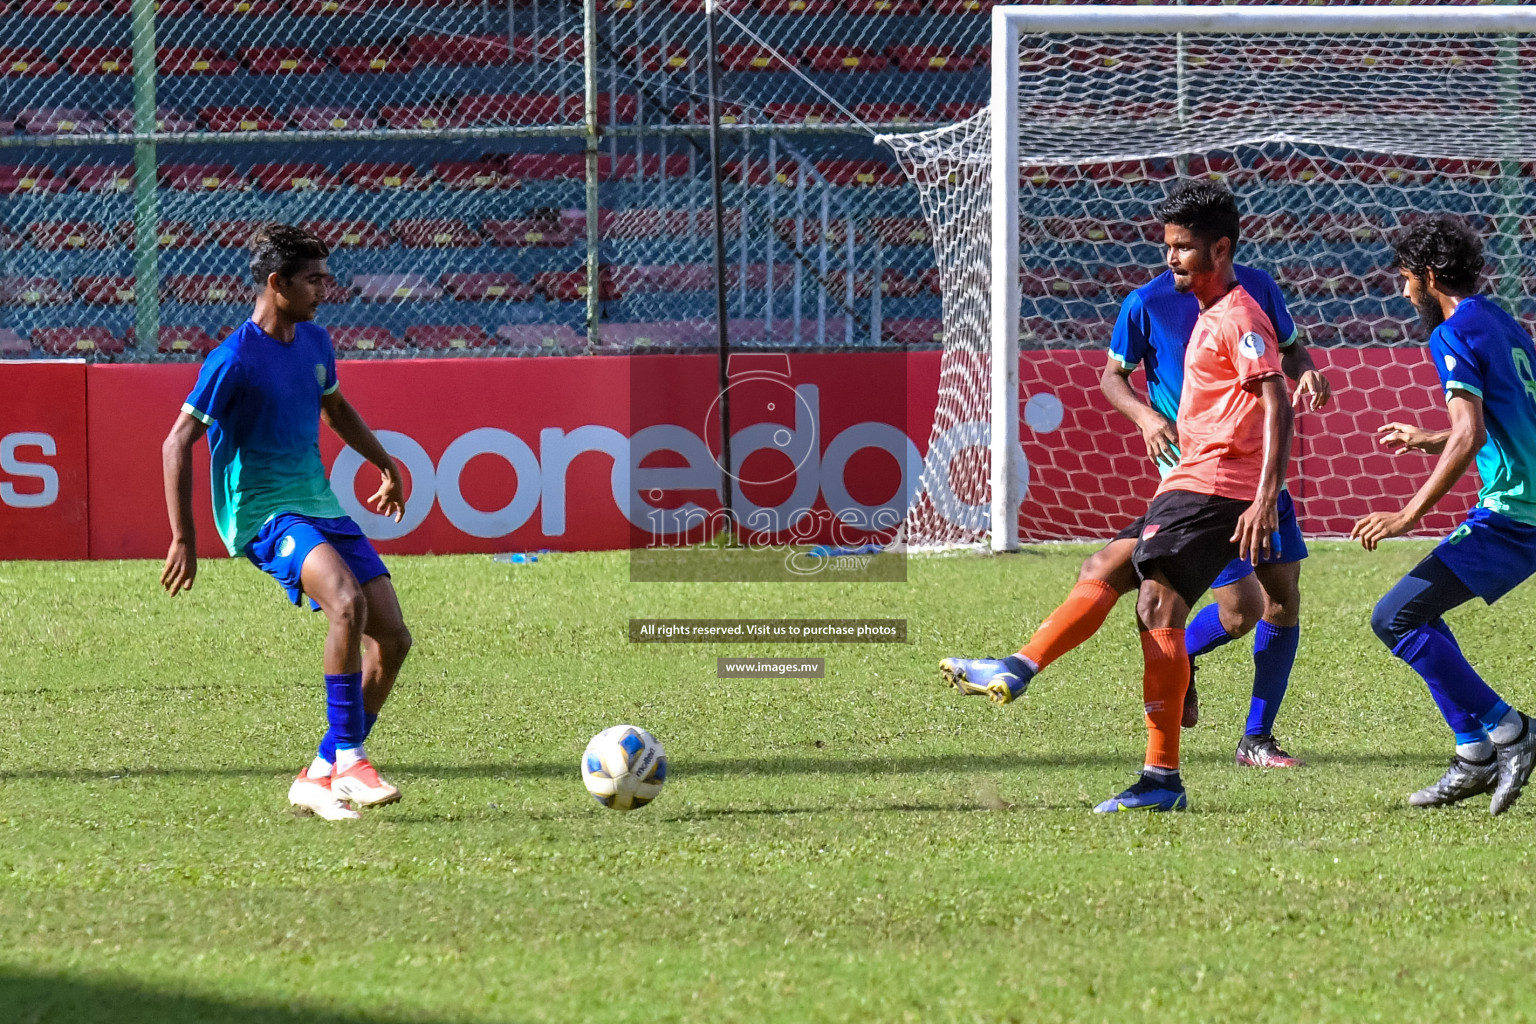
1158,286,1279,500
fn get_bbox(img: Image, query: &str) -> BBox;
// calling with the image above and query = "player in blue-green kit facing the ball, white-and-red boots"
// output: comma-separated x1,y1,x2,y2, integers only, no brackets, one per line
160,224,410,820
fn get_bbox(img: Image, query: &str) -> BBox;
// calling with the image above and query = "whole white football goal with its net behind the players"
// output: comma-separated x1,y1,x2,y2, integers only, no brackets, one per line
883,6,1536,550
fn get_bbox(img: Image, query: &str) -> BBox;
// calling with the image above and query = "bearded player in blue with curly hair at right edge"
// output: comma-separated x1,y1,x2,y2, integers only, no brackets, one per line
1352,216,1536,814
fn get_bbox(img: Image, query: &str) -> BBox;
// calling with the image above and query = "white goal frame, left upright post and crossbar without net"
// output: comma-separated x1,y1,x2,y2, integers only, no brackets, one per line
988,5,1536,551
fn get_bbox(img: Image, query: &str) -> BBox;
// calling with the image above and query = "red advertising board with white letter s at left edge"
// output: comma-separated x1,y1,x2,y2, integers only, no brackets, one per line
0,362,89,559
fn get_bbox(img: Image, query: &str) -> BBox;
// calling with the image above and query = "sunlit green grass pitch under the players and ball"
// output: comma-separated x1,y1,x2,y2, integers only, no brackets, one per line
0,542,1536,1024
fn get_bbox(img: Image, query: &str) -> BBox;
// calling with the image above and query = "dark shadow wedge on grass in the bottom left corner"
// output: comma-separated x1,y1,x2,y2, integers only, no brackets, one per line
0,969,447,1024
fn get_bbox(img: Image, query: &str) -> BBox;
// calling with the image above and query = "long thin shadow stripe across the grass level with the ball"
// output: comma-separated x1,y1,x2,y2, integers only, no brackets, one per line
0,749,1445,781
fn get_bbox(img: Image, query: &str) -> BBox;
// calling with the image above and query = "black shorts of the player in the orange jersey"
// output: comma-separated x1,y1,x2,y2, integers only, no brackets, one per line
1120,491,1253,605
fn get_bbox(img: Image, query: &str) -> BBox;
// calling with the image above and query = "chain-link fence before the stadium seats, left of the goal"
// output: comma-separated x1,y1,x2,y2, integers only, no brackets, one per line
0,0,989,359
